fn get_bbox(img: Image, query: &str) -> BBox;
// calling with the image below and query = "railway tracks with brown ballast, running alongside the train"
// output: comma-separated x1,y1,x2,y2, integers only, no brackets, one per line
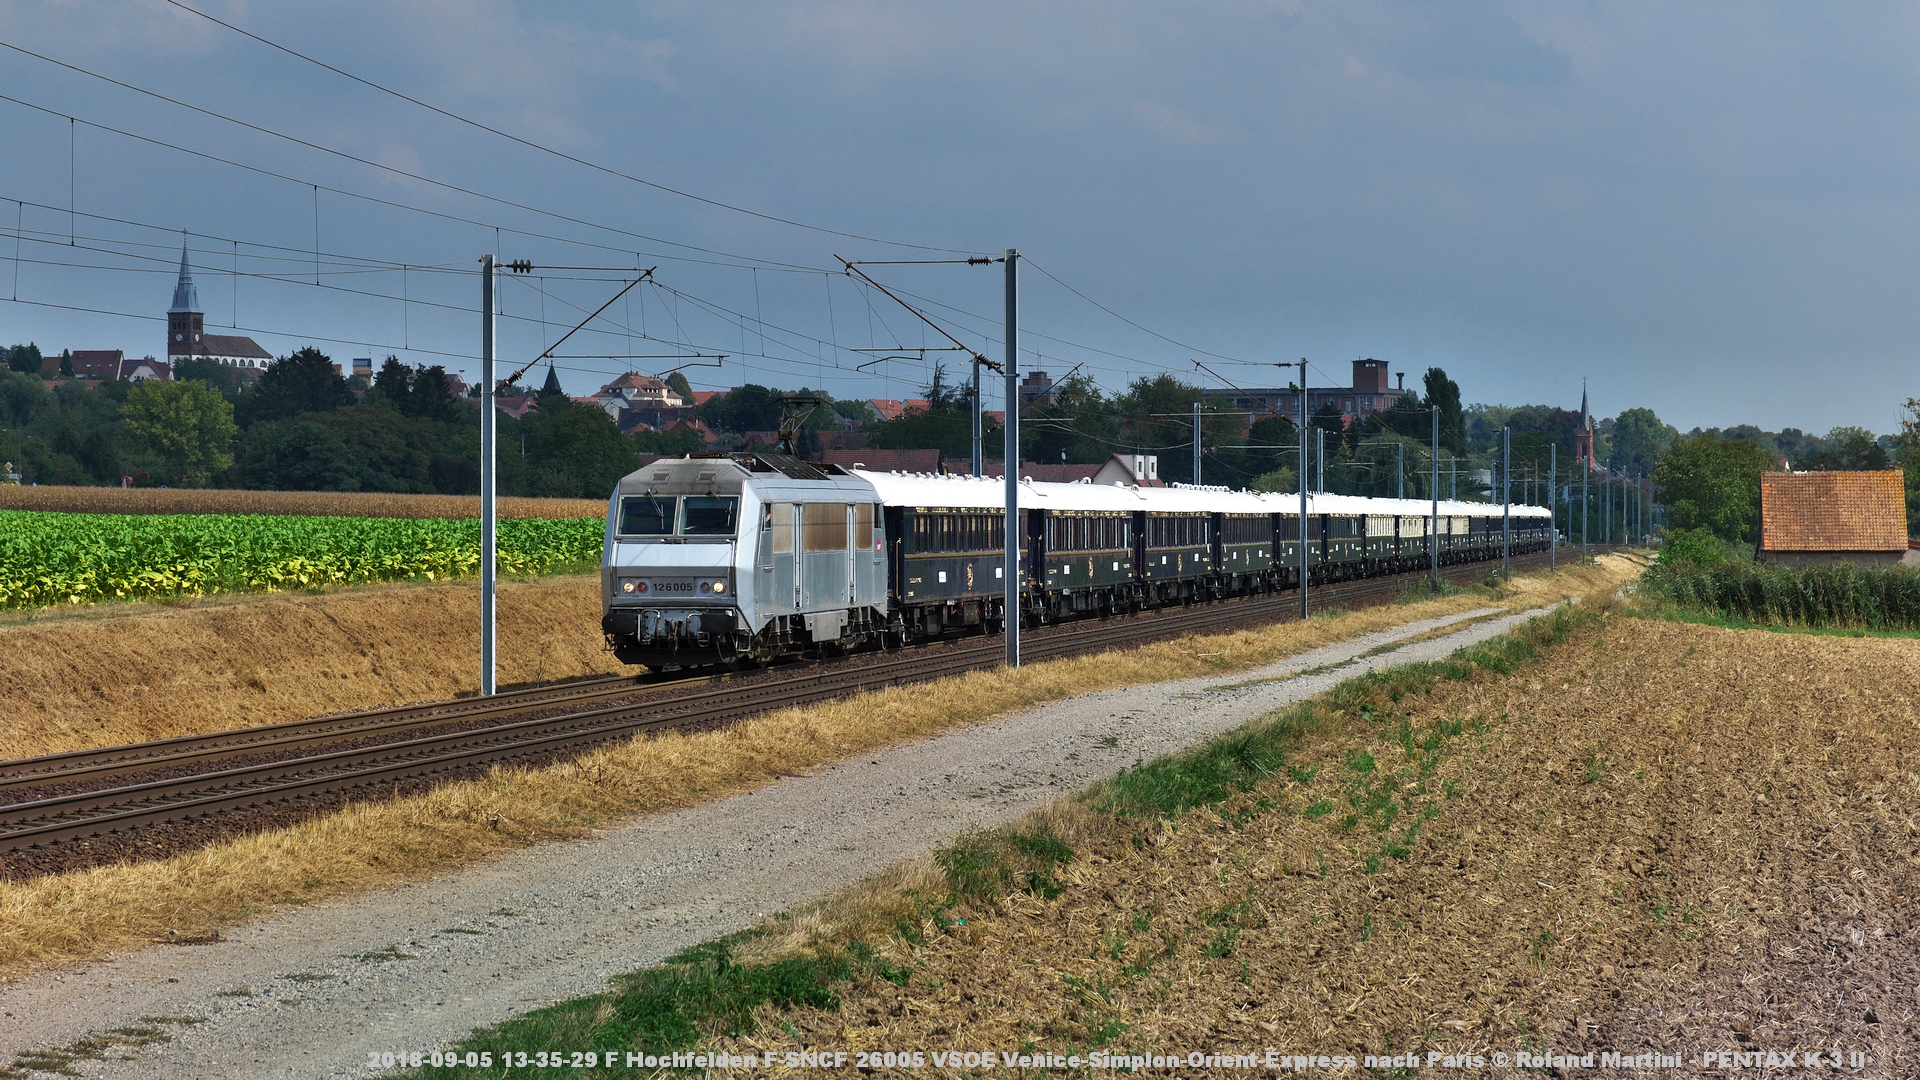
0,553,1548,853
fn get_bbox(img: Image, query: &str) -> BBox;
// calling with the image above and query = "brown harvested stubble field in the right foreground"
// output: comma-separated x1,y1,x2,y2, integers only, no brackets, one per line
718,615,1920,1076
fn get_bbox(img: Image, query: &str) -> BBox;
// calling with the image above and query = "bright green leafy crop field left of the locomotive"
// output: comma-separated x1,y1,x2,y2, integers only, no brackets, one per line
0,511,605,609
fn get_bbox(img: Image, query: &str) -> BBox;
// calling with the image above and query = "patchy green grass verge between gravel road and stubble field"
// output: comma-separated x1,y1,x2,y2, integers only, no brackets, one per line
374,603,1607,1078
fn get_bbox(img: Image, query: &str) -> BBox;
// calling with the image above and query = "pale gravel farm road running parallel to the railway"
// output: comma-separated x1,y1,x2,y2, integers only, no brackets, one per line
0,609,1540,1080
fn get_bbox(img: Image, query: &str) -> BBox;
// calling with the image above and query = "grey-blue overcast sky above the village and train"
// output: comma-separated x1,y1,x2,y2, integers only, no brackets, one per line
0,0,1920,432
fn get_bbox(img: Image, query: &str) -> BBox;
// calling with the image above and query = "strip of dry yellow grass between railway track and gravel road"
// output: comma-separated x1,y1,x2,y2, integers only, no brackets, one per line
0,565,1626,978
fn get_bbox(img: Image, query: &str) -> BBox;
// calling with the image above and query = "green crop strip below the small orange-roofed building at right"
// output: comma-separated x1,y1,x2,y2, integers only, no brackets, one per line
1642,559,1920,630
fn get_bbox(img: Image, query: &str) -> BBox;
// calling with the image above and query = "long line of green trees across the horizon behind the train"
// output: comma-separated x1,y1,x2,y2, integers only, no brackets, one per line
0,336,1920,542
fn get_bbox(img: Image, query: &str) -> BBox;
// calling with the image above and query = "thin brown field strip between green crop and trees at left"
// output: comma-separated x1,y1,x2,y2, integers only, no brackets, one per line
0,484,607,519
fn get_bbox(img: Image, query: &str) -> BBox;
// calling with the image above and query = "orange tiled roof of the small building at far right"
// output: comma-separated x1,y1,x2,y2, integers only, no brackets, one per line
1761,469,1907,552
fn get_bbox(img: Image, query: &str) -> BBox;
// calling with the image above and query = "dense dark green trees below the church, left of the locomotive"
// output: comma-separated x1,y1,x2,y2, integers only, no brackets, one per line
0,348,639,498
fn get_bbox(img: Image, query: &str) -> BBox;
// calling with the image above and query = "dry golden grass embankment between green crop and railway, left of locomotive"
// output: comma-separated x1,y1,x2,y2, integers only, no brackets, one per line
0,577,622,757
